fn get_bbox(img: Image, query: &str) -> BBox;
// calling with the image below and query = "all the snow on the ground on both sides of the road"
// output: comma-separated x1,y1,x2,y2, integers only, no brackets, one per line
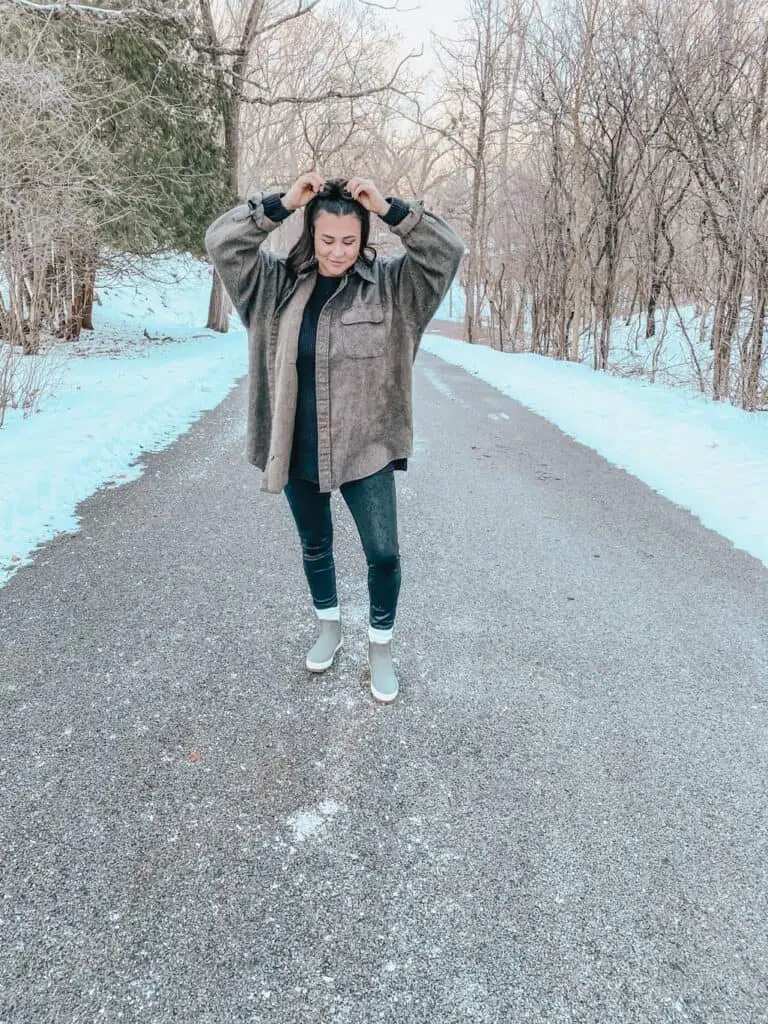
0,257,768,586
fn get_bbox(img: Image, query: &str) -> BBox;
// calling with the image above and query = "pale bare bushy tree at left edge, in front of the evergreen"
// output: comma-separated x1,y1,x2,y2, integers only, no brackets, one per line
0,58,111,353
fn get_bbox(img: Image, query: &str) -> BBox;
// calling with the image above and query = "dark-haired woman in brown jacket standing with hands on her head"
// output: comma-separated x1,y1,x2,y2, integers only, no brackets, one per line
206,171,464,703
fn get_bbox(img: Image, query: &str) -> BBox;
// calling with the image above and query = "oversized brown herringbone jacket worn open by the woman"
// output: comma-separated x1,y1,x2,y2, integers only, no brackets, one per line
206,190,464,494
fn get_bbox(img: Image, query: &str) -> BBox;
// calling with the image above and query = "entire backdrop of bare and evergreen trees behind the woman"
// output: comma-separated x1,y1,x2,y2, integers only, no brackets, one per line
0,0,768,410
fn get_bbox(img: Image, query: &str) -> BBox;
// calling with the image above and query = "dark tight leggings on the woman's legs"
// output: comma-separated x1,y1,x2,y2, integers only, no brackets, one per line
286,468,400,630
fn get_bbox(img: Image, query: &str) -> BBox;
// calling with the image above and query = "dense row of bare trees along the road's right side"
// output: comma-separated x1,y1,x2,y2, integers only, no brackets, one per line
435,0,768,410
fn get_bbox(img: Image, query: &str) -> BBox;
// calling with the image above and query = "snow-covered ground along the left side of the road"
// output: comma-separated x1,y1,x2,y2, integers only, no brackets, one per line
0,258,248,586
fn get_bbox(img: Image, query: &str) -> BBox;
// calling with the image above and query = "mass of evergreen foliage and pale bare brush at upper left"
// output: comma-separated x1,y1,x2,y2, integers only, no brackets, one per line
0,0,232,351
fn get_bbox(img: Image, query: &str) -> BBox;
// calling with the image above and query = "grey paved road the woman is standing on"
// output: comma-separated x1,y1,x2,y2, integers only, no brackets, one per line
0,354,768,1024
